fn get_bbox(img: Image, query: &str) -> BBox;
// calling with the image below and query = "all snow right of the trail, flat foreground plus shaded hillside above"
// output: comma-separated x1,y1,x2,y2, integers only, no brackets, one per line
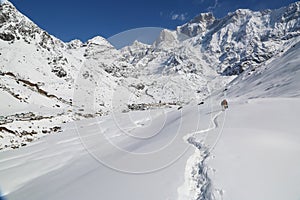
198,30,300,200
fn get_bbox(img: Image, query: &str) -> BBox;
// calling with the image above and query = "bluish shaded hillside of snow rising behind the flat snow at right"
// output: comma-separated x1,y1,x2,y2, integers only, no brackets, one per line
227,37,300,99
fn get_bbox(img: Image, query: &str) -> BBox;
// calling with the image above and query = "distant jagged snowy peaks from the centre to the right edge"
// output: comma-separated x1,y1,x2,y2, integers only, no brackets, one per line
120,2,300,76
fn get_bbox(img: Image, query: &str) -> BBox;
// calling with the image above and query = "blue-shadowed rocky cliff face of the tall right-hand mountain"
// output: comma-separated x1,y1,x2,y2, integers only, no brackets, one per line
177,2,300,76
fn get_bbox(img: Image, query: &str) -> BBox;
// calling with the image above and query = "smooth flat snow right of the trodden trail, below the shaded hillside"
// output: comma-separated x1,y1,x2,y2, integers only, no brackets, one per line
206,98,300,200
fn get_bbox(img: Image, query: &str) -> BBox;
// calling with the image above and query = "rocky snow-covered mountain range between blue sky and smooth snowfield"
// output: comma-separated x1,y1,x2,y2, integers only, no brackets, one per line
0,1,300,152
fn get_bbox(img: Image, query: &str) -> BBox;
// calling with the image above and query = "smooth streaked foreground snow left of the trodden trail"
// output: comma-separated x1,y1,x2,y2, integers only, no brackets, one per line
0,103,214,200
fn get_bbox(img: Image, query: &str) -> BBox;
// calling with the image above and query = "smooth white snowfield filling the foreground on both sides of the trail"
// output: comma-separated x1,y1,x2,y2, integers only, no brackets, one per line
0,98,300,200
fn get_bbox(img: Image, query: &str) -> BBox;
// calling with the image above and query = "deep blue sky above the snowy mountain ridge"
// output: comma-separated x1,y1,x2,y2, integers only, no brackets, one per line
10,0,296,41
